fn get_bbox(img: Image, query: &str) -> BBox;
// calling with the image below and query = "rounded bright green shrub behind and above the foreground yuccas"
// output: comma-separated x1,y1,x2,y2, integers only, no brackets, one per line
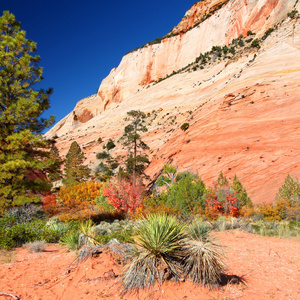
161,172,206,212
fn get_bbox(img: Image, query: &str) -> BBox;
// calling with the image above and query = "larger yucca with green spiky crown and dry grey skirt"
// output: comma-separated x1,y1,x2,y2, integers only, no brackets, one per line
122,214,185,292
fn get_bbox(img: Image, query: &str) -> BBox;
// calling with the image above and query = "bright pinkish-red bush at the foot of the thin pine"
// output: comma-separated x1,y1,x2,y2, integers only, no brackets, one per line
102,178,145,213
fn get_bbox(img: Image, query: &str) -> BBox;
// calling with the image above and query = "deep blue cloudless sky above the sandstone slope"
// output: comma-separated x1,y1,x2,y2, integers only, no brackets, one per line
0,0,195,130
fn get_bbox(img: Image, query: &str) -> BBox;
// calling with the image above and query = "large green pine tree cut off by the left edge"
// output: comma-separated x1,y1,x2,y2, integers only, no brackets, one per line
0,11,54,208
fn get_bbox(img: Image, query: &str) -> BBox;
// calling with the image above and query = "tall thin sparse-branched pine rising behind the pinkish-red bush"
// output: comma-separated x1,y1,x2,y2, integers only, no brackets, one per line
120,110,150,182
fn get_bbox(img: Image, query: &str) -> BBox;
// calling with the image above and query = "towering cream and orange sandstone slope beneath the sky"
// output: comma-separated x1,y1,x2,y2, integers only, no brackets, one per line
46,0,300,202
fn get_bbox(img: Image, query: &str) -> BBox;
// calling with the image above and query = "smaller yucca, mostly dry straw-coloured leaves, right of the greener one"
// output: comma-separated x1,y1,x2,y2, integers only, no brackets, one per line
183,223,226,287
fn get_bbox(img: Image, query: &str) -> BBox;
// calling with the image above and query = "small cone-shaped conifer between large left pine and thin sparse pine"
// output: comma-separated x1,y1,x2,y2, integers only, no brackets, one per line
63,141,90,186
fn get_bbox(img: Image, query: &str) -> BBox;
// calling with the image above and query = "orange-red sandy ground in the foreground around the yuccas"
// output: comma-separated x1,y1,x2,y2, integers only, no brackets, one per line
0,230,300,300
